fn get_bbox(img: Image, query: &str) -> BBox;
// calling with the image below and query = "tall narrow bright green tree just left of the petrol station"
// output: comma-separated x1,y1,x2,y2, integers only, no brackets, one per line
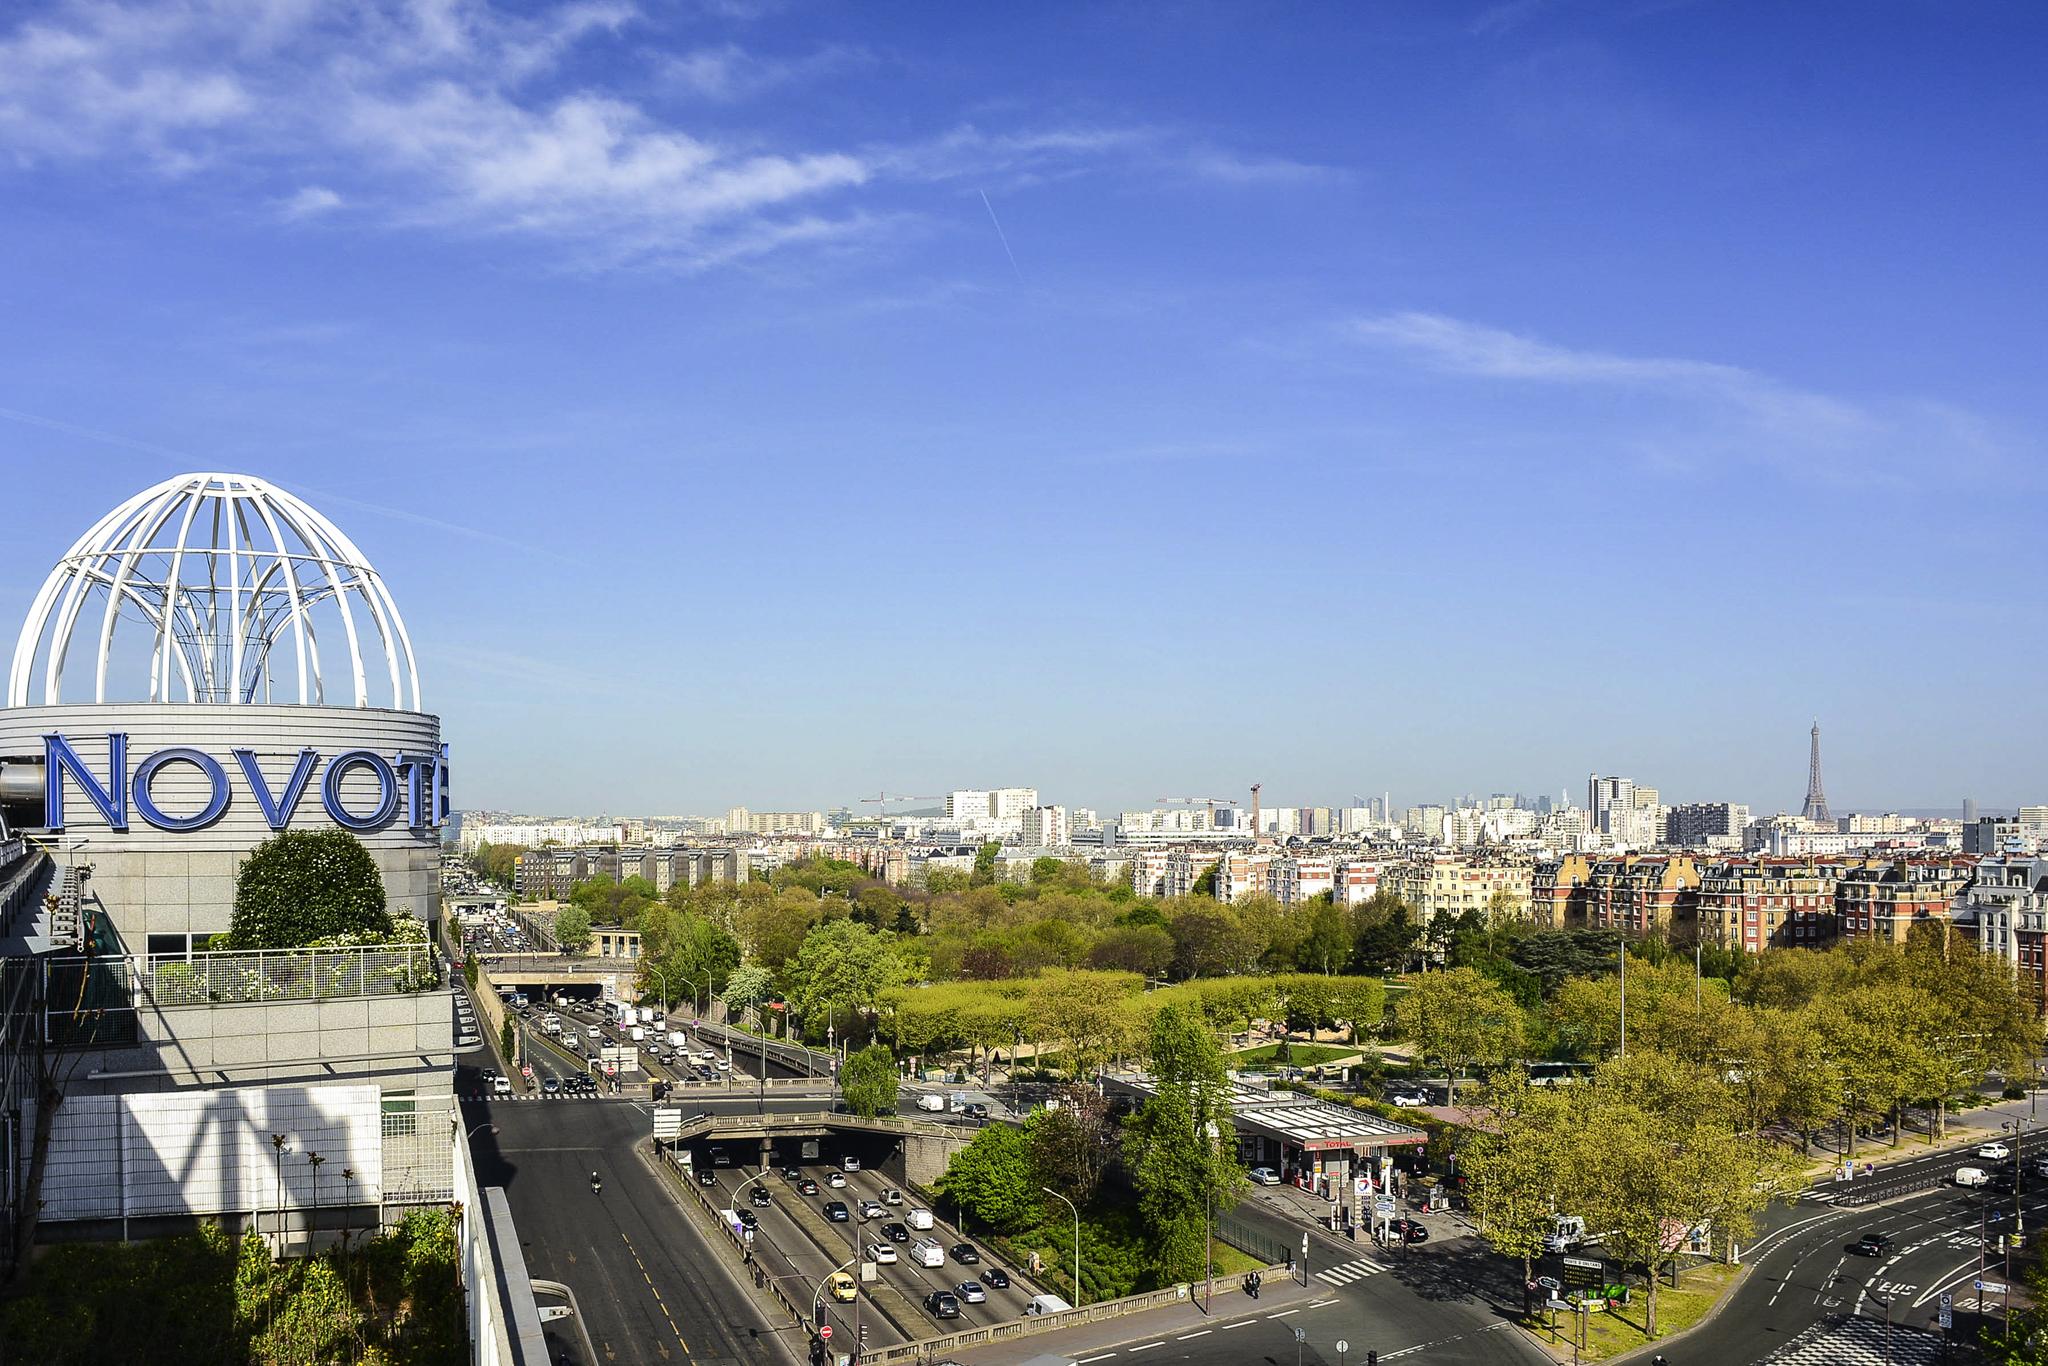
1124,1006,1245,1284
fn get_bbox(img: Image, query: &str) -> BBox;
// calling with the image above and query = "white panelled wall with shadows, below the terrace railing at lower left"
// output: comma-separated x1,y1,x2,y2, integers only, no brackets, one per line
41,1085,383,1223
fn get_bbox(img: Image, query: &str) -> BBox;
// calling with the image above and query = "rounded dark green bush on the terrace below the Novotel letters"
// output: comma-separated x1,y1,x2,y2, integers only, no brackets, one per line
227,829,393,948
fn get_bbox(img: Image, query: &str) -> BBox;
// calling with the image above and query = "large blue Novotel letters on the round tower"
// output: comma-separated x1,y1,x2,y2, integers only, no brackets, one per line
43,731,449,831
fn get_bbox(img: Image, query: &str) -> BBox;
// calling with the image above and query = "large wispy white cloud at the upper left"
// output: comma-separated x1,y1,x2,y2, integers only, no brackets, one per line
0,0,1313,268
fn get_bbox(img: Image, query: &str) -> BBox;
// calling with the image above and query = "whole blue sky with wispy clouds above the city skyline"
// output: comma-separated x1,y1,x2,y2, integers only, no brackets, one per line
0,0,2048,811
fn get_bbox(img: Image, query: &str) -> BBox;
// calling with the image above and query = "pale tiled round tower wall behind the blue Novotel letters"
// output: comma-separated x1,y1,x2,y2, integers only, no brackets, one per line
0,702,440,952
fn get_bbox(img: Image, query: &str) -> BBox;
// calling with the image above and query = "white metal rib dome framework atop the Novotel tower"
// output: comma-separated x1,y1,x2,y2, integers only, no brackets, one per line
6,473,420,711
